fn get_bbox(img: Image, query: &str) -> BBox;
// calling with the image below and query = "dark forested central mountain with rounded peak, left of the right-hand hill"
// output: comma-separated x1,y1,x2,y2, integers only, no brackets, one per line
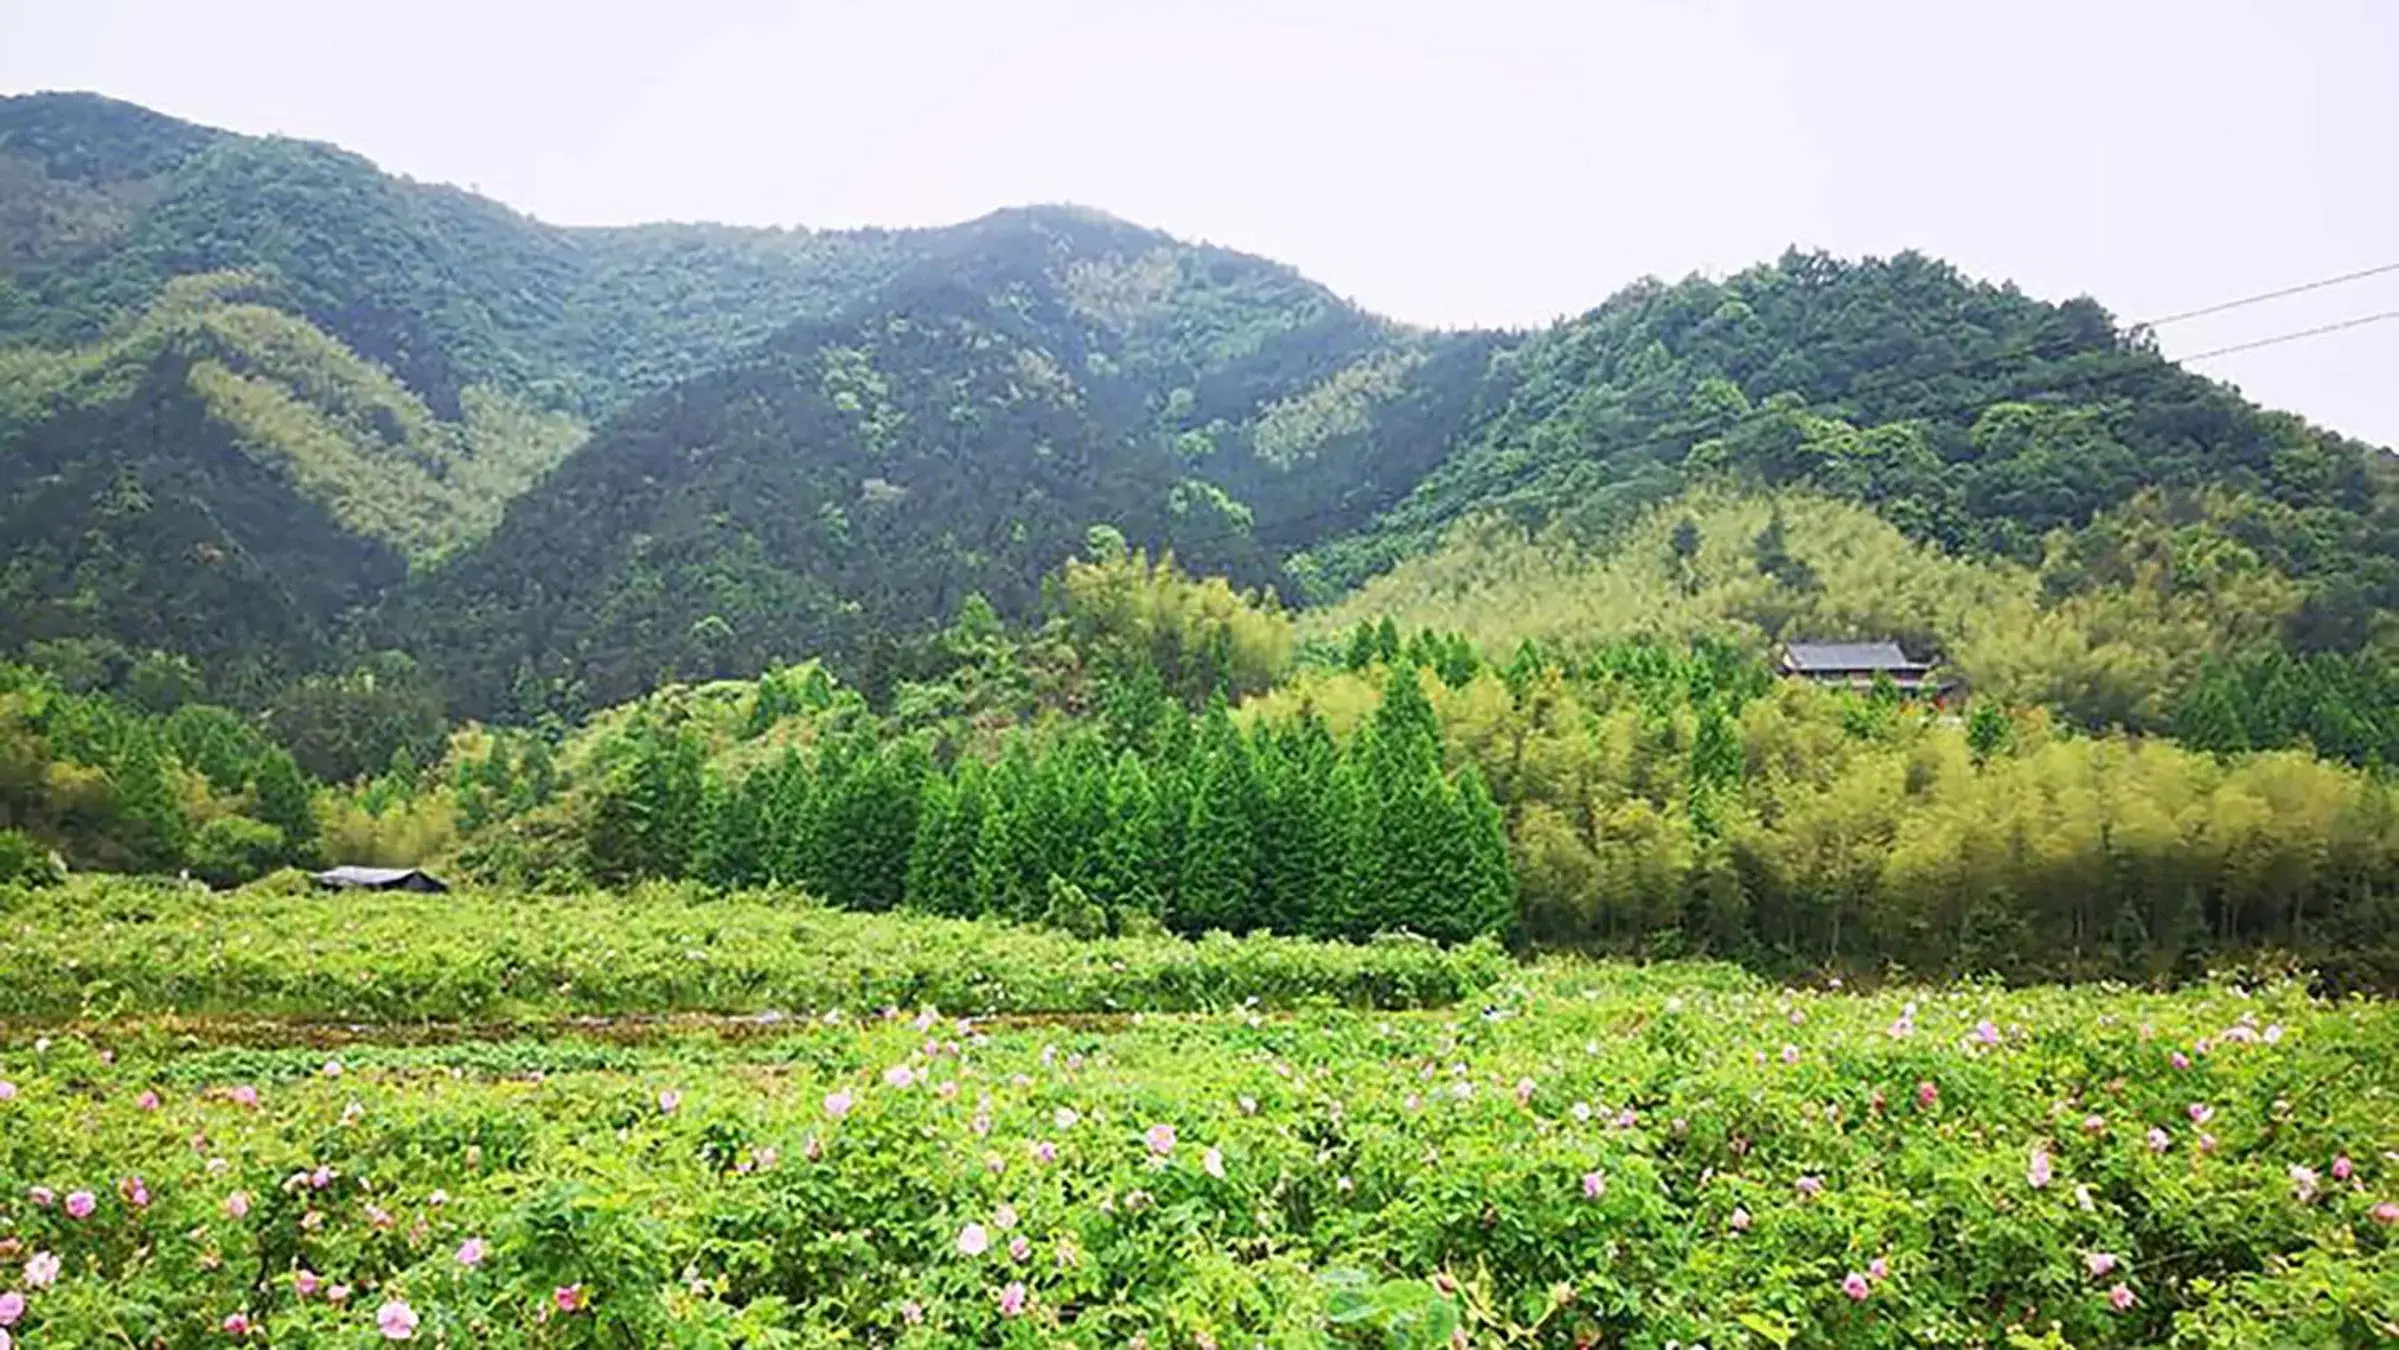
389,209,1485,710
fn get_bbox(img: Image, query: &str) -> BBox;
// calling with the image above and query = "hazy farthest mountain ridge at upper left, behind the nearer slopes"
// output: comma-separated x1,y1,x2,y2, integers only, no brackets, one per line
0,94,919,422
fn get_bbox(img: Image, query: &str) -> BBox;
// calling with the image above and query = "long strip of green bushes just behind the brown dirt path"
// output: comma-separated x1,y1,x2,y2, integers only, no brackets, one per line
0,873,1511,1026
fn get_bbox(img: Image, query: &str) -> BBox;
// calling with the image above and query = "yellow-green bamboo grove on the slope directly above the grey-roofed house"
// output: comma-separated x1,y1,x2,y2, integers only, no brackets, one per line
1307,492,2312,738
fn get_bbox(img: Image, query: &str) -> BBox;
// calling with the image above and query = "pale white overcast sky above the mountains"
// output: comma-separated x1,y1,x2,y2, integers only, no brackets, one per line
0,0,2399,446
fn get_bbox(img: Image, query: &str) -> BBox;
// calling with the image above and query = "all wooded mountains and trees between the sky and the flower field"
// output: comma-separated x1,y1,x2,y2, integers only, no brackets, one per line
0,94,2399,986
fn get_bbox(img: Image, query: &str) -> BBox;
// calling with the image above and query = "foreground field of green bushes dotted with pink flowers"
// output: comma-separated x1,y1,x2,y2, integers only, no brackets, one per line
0,899,2399,1350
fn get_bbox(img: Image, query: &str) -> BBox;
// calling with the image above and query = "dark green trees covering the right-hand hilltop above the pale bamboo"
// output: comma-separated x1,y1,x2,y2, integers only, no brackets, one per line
1305,252,2399,623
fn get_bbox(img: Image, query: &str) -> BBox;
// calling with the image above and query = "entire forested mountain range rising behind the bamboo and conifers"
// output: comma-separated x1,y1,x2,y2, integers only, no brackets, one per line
0,94,2399,724
